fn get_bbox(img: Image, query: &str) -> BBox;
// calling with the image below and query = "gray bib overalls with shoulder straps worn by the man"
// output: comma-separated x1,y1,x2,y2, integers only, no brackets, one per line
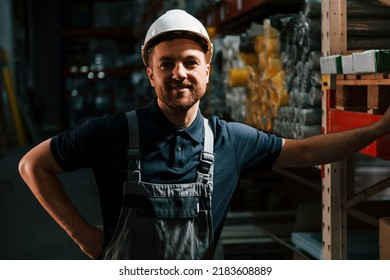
102,111,214,259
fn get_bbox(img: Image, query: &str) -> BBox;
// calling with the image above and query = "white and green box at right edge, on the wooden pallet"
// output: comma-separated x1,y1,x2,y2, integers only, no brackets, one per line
352,50,390,73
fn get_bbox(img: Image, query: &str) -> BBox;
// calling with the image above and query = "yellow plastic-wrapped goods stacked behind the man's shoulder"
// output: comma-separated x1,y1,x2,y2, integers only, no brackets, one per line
228,19,288,131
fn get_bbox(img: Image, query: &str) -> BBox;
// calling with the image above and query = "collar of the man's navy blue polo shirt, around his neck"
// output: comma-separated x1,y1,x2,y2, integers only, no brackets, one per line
148,98,204,143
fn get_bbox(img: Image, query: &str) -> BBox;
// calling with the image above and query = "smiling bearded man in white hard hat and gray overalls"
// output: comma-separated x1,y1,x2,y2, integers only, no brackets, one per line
19,10,390,259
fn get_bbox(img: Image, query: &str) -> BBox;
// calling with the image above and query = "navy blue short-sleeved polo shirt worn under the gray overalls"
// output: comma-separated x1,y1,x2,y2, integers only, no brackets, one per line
51,99,282,248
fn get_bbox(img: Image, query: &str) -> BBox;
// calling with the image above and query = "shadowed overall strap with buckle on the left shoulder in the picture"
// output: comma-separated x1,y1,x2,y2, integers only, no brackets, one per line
126,111,141,181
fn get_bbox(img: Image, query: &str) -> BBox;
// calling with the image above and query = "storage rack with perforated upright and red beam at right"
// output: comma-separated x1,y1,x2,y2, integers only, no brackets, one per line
321,0,390,259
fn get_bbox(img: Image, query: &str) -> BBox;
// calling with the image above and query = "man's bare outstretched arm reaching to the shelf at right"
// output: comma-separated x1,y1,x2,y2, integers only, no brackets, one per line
274,107,390,167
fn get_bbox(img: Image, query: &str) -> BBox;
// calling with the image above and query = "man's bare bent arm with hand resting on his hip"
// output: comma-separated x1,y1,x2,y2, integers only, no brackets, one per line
19,139,104,259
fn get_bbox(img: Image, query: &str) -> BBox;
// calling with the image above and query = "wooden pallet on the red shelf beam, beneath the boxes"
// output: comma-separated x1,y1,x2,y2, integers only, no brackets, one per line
336,73,390,114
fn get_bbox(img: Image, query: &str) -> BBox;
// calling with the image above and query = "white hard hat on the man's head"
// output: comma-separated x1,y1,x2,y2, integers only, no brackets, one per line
141,9,213,66
